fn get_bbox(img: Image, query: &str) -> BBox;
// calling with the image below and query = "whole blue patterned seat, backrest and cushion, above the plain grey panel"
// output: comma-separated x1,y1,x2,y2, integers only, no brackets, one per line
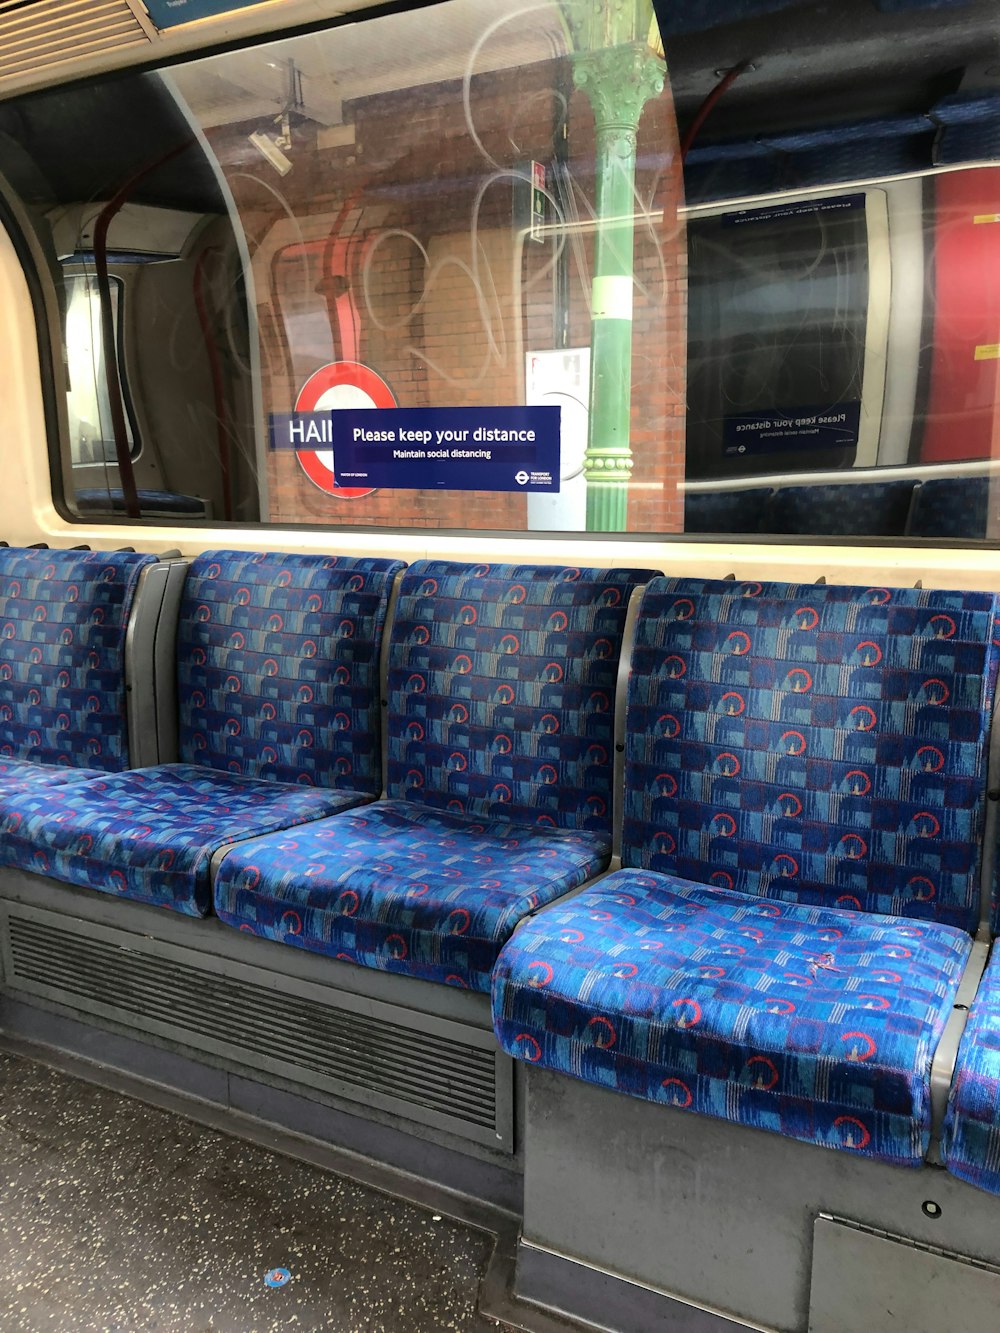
493,579,997,1164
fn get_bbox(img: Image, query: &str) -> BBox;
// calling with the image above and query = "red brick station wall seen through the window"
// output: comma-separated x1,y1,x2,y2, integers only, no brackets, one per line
211,51,687,532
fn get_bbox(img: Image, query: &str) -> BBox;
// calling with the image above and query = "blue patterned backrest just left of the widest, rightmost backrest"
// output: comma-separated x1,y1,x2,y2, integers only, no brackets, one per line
388,560,652,829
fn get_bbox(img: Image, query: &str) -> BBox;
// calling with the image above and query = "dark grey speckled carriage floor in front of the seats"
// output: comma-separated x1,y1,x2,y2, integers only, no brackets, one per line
0,1052,499,1333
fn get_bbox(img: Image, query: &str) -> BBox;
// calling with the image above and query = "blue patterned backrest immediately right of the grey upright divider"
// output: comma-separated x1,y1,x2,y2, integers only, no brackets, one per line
177,551,403,794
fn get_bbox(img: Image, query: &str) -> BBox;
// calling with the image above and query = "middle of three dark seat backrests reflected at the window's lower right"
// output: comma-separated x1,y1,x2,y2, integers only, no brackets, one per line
761,480,913,537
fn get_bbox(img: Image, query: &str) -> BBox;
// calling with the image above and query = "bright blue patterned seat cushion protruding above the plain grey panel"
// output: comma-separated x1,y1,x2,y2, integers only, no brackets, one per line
493,870,971,1165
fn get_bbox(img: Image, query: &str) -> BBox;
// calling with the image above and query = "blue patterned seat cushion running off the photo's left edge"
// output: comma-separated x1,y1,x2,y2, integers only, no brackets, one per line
0,764,364,916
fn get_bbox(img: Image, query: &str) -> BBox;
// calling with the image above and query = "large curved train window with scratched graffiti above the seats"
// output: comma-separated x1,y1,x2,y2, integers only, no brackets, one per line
0,0,1000,540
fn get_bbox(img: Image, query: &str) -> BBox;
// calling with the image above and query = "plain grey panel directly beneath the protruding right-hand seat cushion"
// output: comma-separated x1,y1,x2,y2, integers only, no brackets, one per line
521,1065,1000,1333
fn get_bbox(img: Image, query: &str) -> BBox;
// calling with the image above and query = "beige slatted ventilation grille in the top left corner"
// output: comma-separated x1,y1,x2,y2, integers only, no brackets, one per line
0,0,149,81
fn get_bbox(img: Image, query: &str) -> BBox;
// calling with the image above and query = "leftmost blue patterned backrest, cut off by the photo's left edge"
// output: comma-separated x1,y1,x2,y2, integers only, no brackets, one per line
0,547,157,773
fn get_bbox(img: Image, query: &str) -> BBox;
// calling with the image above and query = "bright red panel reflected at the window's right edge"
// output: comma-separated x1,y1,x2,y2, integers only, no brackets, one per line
921,167,1000,463
